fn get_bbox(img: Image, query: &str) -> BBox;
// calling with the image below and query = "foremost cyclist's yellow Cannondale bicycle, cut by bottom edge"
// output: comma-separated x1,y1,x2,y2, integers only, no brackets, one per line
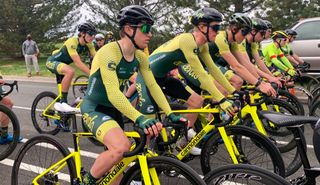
11,111,205,185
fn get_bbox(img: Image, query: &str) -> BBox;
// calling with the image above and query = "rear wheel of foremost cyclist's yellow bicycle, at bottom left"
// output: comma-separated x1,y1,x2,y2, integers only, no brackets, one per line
11,135,76,185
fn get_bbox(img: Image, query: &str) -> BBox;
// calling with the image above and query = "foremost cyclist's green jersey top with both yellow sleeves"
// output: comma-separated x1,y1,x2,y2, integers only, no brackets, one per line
81,42,171,121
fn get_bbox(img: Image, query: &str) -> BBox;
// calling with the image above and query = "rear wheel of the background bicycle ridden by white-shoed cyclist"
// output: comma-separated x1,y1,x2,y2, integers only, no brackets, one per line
31,91,76,135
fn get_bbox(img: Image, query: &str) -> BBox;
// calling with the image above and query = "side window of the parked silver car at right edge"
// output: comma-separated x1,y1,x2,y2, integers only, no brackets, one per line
295,21,320,40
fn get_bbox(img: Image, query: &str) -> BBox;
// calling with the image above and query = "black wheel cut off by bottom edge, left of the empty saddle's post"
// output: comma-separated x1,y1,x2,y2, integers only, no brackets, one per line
203,164,290,185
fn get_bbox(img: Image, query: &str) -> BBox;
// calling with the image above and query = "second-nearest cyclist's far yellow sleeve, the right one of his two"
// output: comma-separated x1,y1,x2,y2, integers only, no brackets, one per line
200,44,235,95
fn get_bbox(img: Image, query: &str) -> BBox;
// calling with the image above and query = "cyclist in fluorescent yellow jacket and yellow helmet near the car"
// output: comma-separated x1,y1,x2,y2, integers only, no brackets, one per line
262,31,296,76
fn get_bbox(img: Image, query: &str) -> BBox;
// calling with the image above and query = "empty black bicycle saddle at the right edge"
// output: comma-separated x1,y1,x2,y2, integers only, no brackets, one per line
259,111,320,127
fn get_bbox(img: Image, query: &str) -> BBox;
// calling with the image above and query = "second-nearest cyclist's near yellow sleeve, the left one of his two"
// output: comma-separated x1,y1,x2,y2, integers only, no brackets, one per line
179,35,224,101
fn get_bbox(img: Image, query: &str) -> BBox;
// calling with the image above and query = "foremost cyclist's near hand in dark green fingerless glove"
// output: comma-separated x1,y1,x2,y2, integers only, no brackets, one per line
135,115,162,137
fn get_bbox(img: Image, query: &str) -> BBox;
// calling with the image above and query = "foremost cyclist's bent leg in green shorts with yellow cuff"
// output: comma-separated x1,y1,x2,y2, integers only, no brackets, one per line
81,100,130,184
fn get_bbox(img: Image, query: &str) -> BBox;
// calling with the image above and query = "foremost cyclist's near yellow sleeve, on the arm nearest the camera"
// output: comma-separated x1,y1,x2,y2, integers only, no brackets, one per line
94,44,142,121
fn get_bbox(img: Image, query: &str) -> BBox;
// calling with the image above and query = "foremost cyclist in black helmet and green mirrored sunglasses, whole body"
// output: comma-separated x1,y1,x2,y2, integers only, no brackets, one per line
81,5,186,184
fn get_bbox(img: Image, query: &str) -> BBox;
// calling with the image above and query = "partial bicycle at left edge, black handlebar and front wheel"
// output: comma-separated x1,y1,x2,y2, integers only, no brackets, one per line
0,81,20,160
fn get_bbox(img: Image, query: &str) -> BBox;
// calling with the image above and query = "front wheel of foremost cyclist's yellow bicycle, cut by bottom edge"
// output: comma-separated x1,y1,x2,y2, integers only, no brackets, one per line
120,156,206,185
